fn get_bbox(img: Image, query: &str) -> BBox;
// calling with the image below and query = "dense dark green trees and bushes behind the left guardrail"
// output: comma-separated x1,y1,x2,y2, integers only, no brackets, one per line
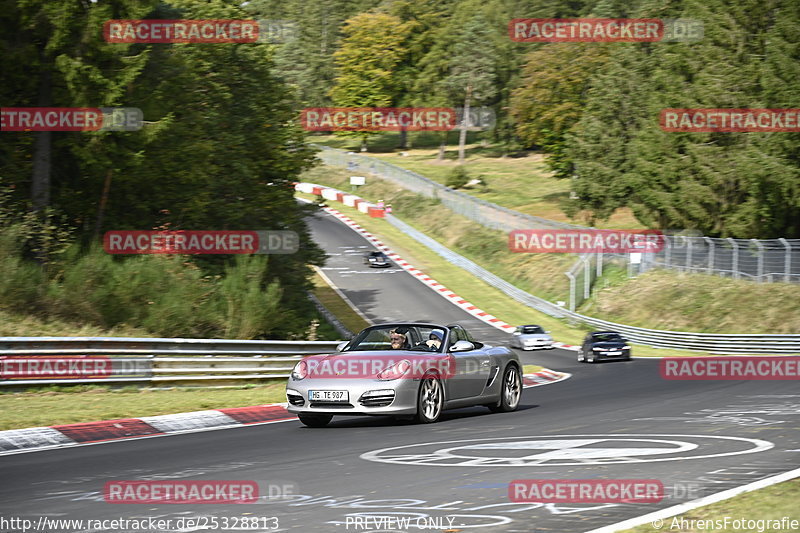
0,0,323,336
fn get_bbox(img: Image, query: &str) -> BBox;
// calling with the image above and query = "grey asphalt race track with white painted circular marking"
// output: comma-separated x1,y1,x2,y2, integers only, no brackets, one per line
0,208,800,533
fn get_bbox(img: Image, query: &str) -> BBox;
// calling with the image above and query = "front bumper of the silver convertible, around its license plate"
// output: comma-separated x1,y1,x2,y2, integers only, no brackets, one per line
286,378,419,415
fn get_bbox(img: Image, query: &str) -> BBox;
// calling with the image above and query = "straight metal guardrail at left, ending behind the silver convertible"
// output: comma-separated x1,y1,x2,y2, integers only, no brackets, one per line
0,337,341,386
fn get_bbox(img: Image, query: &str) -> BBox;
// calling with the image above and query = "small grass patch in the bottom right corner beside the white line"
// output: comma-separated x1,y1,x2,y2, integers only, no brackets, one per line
620,479,800,533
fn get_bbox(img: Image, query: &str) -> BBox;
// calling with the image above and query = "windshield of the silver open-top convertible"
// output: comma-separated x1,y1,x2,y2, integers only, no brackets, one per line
344,324,446,352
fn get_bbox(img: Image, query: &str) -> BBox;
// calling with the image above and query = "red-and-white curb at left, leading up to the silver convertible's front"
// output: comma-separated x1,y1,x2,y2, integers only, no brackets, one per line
0,403,297,455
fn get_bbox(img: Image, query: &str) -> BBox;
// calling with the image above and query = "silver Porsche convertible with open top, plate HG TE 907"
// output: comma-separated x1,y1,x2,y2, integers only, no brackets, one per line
286,322,522,427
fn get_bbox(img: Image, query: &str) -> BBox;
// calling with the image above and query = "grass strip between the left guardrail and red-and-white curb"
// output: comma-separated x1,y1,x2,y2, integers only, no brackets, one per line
0,380,286,430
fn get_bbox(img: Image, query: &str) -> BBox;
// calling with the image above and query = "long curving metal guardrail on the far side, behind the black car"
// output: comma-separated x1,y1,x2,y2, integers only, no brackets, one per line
386,215,800,354
